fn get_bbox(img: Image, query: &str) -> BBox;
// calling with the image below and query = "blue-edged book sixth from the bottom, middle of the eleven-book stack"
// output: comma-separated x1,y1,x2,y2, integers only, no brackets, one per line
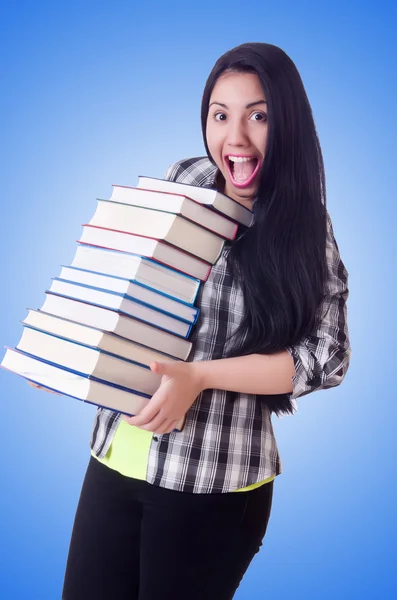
57,266,199,323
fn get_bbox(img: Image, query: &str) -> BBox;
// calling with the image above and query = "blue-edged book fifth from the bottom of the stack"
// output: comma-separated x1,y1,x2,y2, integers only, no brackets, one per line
46,278,192,338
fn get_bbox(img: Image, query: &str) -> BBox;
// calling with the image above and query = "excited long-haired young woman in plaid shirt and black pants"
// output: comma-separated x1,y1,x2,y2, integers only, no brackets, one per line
62,43,350,600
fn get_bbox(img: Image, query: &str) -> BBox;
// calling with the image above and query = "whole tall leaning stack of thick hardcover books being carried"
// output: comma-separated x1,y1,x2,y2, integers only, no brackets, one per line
1,177,253,429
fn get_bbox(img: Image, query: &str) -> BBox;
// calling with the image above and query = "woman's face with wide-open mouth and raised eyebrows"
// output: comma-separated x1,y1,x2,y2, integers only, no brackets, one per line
206,72,267,208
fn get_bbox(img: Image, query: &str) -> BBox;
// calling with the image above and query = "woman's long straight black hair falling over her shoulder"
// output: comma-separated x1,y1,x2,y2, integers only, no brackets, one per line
201,43,326,414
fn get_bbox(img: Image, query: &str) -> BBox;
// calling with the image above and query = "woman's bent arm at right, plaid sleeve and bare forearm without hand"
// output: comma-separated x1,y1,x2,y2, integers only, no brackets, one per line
191,213,351,399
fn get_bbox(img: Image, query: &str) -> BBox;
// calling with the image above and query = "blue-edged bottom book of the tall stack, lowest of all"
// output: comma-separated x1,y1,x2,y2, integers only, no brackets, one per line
1,348,185,431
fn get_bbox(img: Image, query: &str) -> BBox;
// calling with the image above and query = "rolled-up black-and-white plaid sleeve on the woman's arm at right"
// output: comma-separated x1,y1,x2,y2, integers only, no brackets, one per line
286,212,351,400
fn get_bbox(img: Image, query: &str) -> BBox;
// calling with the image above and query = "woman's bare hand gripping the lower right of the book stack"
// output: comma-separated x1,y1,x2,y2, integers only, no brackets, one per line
122,361,203,434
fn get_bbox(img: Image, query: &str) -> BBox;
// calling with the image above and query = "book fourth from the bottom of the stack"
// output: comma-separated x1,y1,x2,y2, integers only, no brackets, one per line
40,293,192,360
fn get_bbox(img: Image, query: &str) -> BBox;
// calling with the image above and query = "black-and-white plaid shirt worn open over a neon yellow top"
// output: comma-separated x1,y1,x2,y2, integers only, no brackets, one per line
91,157,351,493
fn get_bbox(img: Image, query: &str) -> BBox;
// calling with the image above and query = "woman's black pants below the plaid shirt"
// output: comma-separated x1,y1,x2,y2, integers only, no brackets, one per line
62,457,273,600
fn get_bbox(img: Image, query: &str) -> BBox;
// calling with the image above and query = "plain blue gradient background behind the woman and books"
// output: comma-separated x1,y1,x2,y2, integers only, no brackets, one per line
0,0,397,600
